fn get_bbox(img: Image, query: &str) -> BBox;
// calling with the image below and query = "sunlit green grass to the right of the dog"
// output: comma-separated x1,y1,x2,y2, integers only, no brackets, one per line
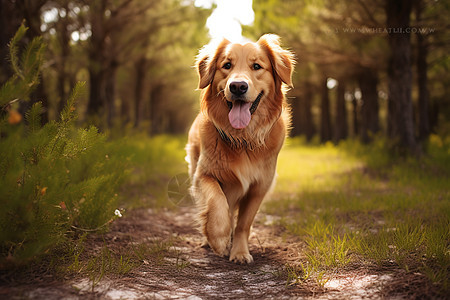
264,136,450,292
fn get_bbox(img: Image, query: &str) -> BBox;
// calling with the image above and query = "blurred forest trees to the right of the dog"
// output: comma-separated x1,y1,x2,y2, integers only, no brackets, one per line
246,0,450,153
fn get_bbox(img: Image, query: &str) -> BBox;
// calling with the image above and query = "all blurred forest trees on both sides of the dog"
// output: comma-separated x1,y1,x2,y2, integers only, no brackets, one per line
0,0,450,153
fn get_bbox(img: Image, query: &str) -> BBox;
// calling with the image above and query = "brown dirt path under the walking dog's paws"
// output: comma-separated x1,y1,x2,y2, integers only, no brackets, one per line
0,207,428,299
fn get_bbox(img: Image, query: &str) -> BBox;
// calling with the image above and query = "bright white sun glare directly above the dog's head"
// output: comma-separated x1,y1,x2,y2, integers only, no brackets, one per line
195,0,255,43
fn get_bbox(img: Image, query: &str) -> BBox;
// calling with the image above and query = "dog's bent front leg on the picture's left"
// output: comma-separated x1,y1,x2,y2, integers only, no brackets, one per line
194,175,232,256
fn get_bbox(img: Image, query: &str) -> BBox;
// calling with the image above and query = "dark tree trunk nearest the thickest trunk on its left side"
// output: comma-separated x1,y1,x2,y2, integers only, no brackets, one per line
359,68,380,144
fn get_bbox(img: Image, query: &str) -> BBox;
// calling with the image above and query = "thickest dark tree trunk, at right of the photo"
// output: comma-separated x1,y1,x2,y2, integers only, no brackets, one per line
386,0,418,154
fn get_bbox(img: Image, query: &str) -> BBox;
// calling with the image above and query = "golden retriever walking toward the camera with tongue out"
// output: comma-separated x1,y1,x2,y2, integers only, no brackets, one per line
186,34,294,263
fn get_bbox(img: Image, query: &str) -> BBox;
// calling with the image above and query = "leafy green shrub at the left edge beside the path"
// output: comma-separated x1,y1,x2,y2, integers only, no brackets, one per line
0,26,125,265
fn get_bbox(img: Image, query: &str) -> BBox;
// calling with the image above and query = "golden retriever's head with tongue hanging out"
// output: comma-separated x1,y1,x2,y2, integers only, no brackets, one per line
197,34,294,134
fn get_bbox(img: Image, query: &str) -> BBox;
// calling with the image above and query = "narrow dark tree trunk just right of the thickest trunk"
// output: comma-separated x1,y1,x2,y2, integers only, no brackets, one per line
415,0,430,140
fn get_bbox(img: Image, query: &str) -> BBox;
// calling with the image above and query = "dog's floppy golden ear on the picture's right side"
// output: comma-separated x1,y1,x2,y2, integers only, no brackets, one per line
257,34,295,87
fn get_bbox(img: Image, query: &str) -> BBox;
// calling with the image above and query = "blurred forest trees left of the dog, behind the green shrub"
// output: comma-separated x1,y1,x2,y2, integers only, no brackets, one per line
0,0,211,134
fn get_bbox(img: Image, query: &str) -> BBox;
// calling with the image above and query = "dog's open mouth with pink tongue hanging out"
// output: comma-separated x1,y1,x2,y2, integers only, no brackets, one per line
227,92,264,129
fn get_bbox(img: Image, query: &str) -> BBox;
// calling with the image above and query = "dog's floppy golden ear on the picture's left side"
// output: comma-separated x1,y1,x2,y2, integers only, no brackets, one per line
196,39,230,89
